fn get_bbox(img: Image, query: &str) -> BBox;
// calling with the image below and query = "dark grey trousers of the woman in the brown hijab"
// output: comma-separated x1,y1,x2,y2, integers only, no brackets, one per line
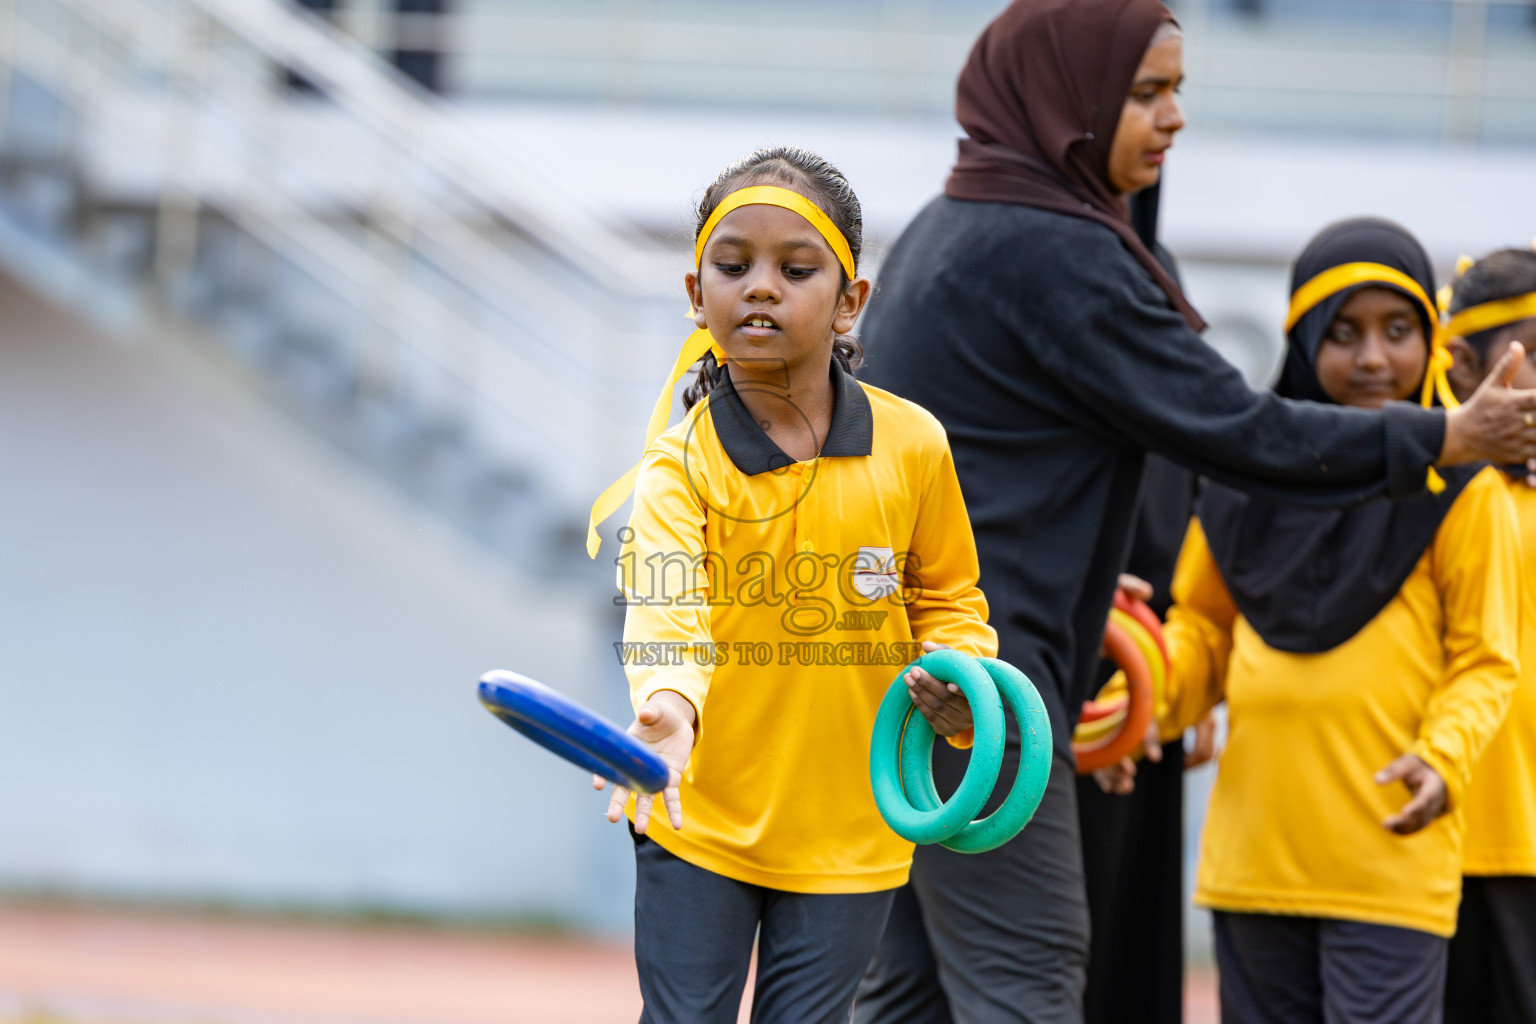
854,752,1087,1024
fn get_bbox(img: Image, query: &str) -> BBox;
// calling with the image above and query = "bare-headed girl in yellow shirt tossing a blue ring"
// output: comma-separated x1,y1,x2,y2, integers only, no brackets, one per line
590,149,997,1024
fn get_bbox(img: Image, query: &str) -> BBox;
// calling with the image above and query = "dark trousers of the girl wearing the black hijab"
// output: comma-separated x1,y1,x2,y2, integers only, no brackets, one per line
1213,910,1448,1024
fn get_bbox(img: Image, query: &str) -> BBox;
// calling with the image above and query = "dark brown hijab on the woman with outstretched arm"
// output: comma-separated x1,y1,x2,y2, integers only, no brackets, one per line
945,0,1206,330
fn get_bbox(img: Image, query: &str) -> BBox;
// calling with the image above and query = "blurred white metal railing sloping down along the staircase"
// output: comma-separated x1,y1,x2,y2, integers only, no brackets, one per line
0,0,676,502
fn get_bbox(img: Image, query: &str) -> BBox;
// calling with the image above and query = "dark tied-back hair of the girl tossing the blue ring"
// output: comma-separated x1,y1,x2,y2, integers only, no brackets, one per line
682,146,863,408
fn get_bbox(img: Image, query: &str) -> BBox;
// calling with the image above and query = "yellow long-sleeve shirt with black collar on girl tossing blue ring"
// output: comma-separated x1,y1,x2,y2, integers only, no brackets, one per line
619,368,997,892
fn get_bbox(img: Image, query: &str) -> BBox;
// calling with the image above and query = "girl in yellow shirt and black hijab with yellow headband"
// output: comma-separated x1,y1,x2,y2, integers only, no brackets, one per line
1105,220,1519,1024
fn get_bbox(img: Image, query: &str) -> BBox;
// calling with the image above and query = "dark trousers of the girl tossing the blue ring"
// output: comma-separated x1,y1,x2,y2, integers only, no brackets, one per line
631,829,891,1024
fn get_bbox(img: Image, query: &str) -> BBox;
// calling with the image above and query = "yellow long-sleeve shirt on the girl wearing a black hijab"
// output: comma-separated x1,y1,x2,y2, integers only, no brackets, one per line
1166,468,1521,935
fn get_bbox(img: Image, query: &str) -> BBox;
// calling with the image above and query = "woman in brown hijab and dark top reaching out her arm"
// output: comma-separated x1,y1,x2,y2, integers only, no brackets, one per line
856,0,1536,1024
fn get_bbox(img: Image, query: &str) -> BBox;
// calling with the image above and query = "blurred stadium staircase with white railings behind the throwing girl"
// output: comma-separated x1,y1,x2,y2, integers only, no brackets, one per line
0,0,680,573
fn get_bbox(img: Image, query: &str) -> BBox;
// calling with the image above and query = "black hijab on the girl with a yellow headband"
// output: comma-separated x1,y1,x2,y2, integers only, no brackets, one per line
1198,218,1479,654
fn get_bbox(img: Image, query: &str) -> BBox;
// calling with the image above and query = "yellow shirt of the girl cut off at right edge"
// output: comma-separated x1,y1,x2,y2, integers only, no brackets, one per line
1462,482,1536,875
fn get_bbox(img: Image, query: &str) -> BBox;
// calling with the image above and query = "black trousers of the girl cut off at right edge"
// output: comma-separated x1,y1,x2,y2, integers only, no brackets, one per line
1445,875,1536,1024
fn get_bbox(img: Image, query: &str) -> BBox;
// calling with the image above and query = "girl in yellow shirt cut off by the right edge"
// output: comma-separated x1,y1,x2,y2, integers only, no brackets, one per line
1445,249,1536,1024
